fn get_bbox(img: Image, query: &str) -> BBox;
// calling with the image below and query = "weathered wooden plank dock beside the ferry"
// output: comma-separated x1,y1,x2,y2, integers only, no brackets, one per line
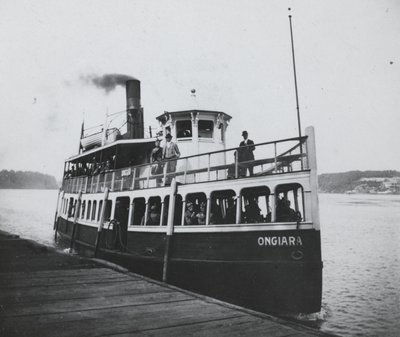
0,232,334,337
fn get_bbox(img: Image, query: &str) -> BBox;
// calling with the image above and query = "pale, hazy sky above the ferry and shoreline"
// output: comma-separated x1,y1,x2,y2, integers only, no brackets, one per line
0,0,400,179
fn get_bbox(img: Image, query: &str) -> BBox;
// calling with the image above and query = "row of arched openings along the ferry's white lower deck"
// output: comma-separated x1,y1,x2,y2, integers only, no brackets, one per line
62,184,305,226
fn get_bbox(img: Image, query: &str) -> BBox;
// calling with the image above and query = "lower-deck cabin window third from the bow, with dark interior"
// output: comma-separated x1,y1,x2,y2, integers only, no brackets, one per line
210,190,236,225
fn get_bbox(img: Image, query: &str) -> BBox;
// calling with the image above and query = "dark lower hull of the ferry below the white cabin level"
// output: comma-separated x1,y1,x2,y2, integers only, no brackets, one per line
58,218,322,314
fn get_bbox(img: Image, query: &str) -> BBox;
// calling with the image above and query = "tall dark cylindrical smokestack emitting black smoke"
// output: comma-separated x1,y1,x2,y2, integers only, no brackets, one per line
126,80,144,139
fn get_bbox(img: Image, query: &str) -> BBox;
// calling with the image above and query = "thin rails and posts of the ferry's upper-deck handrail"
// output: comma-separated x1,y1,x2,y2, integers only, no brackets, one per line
63,136,307,193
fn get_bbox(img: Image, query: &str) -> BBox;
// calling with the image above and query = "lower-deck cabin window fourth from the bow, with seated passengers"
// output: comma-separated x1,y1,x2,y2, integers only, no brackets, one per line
184,193,207,226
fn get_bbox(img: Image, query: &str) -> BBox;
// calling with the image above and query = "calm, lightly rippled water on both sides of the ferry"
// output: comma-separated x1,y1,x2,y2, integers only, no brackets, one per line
0,190,400,336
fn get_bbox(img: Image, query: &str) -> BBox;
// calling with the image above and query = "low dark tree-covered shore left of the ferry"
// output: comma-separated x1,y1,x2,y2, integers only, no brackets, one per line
0,170,58,189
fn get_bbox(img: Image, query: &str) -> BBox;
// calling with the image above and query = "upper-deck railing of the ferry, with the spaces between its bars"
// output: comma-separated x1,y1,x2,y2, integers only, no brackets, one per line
63,137,308,193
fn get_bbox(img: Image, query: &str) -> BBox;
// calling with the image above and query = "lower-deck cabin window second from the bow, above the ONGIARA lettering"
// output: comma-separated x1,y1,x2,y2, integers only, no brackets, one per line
241,186,271,223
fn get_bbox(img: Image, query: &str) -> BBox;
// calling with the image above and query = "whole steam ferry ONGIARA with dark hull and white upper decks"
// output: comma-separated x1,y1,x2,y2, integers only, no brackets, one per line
54,80,322,315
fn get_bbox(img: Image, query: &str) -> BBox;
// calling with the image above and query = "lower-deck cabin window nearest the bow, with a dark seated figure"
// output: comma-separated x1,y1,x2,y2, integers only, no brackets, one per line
275,184,305,222
